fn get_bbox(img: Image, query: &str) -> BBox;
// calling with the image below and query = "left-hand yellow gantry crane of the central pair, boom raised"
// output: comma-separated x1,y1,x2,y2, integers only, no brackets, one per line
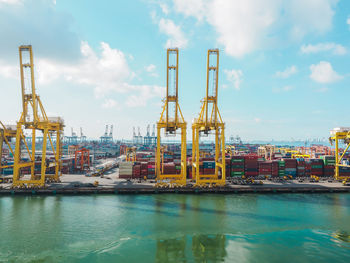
156,48,187,186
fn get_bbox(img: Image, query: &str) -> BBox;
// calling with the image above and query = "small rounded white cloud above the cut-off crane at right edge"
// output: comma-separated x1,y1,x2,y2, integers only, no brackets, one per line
310,61,343,83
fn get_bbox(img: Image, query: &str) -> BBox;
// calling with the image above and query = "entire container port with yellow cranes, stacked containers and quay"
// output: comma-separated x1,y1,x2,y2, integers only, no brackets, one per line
0,45,350,195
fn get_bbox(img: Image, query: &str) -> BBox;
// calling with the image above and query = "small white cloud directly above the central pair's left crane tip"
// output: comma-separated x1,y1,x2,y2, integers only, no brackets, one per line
158,18,188,48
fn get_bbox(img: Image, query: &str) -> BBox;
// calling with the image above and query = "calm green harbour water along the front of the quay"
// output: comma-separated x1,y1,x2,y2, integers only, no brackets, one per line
0,194,350,263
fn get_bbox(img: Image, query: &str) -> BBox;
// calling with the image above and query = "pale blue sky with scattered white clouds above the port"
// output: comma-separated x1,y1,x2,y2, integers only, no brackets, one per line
0,0,350,141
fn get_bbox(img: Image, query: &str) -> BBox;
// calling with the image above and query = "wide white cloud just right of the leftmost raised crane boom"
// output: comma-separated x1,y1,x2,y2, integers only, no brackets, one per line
36,42,133,97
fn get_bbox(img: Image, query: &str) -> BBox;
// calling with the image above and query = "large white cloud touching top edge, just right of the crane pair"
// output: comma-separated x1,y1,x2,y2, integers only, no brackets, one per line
206,0,276,57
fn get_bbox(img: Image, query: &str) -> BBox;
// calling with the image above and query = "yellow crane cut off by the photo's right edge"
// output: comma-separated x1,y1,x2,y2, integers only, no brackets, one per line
329,128,350,180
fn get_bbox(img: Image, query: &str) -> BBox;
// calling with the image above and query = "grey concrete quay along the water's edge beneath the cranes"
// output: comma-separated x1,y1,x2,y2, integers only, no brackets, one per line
0,173,350,195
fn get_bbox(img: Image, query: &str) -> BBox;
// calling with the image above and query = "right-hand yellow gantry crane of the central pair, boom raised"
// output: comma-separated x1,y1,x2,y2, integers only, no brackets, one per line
192,49,226,187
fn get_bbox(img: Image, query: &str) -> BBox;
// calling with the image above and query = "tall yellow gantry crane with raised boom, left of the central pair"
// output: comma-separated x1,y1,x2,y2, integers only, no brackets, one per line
13,45,64,187
